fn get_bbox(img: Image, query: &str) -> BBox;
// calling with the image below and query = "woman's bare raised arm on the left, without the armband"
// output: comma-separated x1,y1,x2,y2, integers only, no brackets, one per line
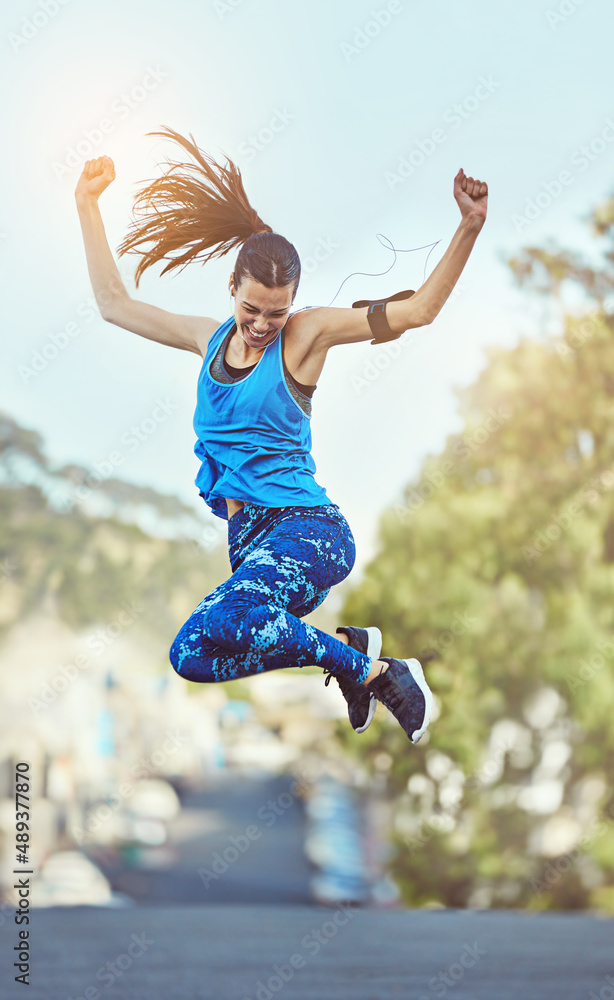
75,156,219,356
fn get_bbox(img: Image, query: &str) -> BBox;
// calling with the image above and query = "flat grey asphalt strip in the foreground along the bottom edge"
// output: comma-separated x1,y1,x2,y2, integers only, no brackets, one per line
6,903,614,1000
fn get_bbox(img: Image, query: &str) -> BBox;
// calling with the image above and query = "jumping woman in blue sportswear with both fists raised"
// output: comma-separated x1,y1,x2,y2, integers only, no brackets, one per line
75,129,488,743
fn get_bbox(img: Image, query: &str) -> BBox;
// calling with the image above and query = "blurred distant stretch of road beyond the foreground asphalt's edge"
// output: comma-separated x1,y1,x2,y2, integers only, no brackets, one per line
95,775,318,906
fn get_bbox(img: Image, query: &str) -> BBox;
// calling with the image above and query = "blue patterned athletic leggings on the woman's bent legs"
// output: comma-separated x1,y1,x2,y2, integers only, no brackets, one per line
169,503,373,684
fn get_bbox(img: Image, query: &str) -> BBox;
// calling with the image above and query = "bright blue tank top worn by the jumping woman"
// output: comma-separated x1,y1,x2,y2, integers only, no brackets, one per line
194,316,331,520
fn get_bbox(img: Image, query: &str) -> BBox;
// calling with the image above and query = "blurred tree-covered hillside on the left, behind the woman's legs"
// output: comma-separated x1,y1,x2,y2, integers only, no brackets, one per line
0,414,228,652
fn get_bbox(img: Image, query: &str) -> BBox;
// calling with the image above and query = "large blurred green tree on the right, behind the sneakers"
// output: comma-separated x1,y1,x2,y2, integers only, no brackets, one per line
339,189,614,912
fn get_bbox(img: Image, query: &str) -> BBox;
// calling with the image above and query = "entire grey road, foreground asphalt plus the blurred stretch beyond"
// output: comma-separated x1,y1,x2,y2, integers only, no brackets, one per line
0,776,614,1000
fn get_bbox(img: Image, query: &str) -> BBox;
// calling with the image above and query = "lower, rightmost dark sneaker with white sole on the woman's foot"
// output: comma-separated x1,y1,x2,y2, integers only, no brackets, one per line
366,656,433,743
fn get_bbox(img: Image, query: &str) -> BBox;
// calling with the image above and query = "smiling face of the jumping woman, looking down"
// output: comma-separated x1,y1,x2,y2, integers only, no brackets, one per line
229,275,294,348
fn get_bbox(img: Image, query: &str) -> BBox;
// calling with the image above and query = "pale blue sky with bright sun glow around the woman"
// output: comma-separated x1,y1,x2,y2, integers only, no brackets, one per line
0,0,614,567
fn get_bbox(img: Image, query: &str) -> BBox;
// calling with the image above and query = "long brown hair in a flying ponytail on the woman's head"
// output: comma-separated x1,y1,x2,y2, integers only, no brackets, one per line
117,126,301,299
